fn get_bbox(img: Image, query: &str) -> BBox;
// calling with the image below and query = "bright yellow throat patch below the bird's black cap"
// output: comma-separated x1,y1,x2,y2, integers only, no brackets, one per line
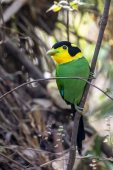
52,52,83,65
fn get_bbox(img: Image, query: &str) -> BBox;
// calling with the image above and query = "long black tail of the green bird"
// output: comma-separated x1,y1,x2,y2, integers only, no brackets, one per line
71,104,85,155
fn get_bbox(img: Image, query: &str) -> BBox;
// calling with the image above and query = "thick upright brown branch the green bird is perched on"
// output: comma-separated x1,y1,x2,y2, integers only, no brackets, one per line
67,0,111,170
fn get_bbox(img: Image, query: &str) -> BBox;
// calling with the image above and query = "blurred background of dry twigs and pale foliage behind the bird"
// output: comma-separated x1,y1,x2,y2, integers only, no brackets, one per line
0,0,113,170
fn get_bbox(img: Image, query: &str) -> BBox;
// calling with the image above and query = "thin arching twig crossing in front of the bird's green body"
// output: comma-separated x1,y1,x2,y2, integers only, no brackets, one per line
0,77,113,100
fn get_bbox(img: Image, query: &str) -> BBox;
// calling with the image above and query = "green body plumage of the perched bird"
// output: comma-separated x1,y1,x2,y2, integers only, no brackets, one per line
56,57,90,105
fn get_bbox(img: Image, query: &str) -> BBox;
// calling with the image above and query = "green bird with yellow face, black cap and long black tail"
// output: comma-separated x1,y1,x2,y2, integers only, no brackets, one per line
47,41,90,155
